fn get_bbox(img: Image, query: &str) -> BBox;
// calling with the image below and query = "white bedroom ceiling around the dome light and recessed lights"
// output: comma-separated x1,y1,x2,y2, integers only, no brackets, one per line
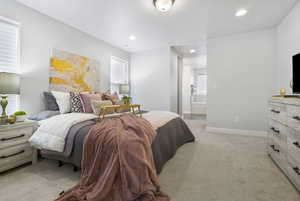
18,0,298,52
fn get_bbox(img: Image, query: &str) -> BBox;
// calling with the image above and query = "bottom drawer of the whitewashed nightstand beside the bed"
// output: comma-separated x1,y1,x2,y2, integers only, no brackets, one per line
0,143,33,170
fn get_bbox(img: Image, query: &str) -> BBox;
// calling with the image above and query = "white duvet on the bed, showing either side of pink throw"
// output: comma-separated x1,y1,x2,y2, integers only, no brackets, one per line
29,111,179,152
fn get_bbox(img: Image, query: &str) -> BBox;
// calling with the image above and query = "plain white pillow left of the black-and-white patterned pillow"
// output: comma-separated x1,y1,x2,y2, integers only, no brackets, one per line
51,91,71,114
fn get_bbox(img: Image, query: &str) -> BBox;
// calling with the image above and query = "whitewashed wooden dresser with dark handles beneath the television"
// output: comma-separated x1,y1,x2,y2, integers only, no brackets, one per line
267,97,300,190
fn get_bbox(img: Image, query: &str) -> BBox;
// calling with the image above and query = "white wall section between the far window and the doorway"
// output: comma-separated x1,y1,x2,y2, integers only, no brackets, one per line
131,48,171,111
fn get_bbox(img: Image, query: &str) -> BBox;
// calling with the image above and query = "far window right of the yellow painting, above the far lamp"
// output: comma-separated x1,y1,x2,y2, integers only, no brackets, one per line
110,57,129,93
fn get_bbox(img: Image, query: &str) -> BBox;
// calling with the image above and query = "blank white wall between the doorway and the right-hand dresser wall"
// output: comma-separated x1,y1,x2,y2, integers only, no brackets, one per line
207,29,276,130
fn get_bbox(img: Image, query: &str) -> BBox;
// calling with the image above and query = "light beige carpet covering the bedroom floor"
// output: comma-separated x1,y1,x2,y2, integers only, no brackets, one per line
0,121,300,201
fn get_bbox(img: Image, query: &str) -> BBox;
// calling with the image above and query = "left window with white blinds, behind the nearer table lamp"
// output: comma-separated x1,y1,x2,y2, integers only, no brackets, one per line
0,16,20,114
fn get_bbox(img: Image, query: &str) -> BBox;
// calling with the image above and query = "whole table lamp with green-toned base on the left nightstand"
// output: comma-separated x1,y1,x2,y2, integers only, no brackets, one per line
0,72,20,124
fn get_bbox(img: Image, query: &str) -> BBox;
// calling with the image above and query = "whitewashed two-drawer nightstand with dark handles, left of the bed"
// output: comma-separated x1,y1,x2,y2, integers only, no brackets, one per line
0,120,38,173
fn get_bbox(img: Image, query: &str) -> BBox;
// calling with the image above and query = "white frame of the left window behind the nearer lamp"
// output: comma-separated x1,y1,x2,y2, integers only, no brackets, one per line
0,16,21,114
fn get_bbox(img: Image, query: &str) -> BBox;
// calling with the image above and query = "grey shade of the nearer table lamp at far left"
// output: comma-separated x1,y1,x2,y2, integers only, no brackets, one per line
0,72,20,94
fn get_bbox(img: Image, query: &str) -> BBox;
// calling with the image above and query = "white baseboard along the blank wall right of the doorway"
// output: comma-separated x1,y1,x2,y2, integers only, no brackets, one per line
206,127,268,137
